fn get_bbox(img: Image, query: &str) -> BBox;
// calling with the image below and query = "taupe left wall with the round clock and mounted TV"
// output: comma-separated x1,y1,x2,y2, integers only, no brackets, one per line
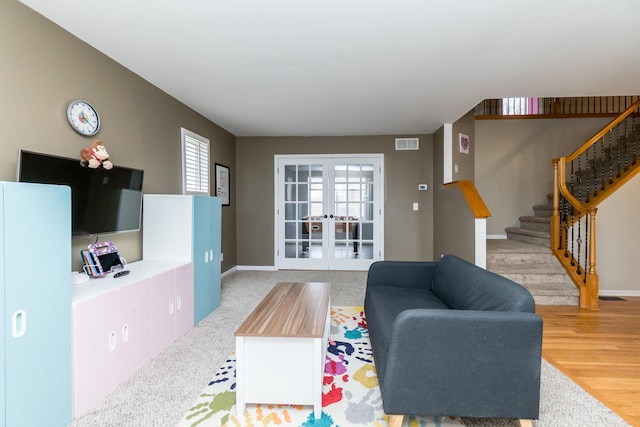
0,0,236,270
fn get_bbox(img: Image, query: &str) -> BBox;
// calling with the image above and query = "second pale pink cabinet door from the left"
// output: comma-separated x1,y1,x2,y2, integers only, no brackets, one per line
119,278,153,378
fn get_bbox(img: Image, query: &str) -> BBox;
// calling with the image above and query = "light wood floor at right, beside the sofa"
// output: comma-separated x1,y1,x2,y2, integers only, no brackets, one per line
536,297,640,427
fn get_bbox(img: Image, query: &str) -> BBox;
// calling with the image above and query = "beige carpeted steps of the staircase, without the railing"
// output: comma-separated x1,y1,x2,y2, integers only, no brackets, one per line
487,196,580,306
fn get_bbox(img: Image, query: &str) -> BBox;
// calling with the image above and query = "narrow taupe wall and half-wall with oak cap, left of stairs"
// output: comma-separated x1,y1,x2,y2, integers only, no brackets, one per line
433,112,484,263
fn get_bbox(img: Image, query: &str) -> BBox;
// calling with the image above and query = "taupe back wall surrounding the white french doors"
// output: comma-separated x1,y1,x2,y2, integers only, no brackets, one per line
236,135,433,266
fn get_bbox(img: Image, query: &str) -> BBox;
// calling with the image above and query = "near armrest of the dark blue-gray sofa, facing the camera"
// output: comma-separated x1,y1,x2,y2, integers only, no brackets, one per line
381,309,542,419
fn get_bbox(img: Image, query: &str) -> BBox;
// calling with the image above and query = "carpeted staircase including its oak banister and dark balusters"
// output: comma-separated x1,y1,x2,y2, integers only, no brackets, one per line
487,100,640,310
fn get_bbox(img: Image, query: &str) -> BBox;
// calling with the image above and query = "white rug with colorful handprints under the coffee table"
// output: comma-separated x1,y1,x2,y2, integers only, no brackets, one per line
178,307,464,427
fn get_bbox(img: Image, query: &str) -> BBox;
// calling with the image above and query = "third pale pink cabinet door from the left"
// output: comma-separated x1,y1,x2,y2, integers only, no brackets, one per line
151,270,176,356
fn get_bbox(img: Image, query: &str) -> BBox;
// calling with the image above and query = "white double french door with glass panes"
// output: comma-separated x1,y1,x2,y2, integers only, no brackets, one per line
275,154,384,270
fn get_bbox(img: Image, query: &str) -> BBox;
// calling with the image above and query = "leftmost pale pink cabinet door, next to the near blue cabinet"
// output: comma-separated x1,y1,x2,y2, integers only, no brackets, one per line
72,290,125,418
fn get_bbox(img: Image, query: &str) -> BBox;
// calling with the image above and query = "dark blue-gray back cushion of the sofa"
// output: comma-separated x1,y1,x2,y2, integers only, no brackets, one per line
431,255,535,313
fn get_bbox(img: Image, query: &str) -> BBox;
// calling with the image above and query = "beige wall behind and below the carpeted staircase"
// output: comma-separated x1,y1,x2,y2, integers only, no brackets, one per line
475,118,640,295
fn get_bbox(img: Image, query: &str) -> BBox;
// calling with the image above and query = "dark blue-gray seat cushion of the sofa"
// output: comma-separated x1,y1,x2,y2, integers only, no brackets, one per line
365,286,449,382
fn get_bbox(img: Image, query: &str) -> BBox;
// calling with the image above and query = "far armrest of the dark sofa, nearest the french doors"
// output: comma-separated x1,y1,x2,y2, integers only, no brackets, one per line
367,261,438,289
